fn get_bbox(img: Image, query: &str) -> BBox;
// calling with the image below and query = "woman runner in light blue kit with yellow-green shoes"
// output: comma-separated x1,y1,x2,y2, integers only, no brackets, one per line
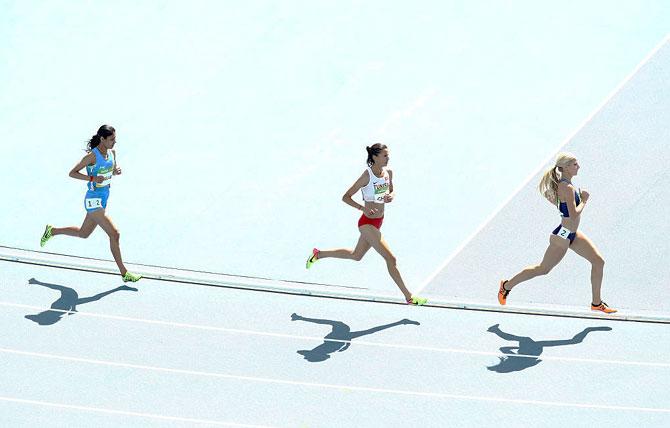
40,125,142,282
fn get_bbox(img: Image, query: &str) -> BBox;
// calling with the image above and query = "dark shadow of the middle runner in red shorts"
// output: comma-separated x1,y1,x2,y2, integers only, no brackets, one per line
291,314,420,363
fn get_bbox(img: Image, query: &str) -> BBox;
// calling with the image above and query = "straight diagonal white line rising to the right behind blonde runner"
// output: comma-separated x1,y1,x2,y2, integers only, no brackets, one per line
415,34,670,294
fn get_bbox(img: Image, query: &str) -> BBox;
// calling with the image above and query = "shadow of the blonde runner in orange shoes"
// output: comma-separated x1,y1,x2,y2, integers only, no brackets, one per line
487,324,612,373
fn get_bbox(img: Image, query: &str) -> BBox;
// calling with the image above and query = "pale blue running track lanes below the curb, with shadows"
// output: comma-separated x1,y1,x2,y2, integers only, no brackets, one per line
0,261,670,427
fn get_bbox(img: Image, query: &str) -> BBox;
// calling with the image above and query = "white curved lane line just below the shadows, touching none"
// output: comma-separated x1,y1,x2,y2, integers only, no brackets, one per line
0,348,670,413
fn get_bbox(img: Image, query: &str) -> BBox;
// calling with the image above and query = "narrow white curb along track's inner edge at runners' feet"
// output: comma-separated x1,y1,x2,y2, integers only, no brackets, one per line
0,253,670,324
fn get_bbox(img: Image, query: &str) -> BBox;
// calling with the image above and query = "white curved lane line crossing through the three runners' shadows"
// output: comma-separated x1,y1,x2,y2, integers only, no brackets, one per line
6,302,670,368
